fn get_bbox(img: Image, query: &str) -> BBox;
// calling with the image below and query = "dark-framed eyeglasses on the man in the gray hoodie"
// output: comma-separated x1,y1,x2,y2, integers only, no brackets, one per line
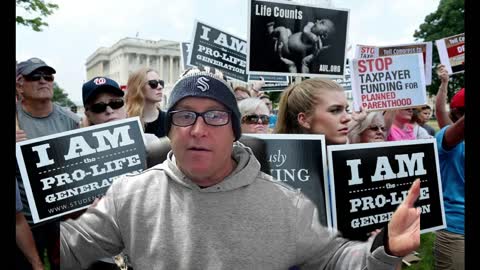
170,110,231,127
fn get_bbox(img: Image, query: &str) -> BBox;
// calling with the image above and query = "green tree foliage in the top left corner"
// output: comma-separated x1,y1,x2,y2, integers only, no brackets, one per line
16,0,58,32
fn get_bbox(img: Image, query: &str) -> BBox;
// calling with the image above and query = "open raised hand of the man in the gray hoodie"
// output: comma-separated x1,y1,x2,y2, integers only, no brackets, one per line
388,179,421,257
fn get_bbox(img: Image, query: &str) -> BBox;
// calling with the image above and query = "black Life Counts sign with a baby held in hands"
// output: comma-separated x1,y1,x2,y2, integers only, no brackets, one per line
247,0,349,78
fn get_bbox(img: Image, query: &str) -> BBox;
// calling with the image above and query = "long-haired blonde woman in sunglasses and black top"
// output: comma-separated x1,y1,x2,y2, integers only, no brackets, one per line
126,67,167,137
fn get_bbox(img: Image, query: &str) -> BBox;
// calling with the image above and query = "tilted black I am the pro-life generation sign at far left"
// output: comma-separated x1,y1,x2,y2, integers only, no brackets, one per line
16,117,146,223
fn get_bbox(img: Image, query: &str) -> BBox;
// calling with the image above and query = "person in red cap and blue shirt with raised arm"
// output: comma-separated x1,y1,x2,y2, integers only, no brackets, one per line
434,65,465,269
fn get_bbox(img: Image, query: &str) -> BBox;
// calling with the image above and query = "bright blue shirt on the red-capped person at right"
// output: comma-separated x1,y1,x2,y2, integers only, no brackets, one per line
435,126,465,235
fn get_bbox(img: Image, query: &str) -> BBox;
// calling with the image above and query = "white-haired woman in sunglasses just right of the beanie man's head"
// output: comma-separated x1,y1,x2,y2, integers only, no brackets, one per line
238,98,270,133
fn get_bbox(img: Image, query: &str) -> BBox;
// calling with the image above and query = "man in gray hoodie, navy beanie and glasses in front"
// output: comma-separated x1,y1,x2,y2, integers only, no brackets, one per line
60,67,420,270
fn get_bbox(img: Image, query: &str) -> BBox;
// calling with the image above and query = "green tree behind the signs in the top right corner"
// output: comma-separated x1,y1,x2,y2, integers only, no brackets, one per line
413,0,465,100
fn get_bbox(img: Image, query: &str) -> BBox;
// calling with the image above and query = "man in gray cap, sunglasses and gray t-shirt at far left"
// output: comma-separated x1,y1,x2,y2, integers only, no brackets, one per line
16,58,80,269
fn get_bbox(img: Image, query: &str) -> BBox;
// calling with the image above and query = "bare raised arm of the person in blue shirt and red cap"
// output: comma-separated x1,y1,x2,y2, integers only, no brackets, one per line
435,65,452,128
